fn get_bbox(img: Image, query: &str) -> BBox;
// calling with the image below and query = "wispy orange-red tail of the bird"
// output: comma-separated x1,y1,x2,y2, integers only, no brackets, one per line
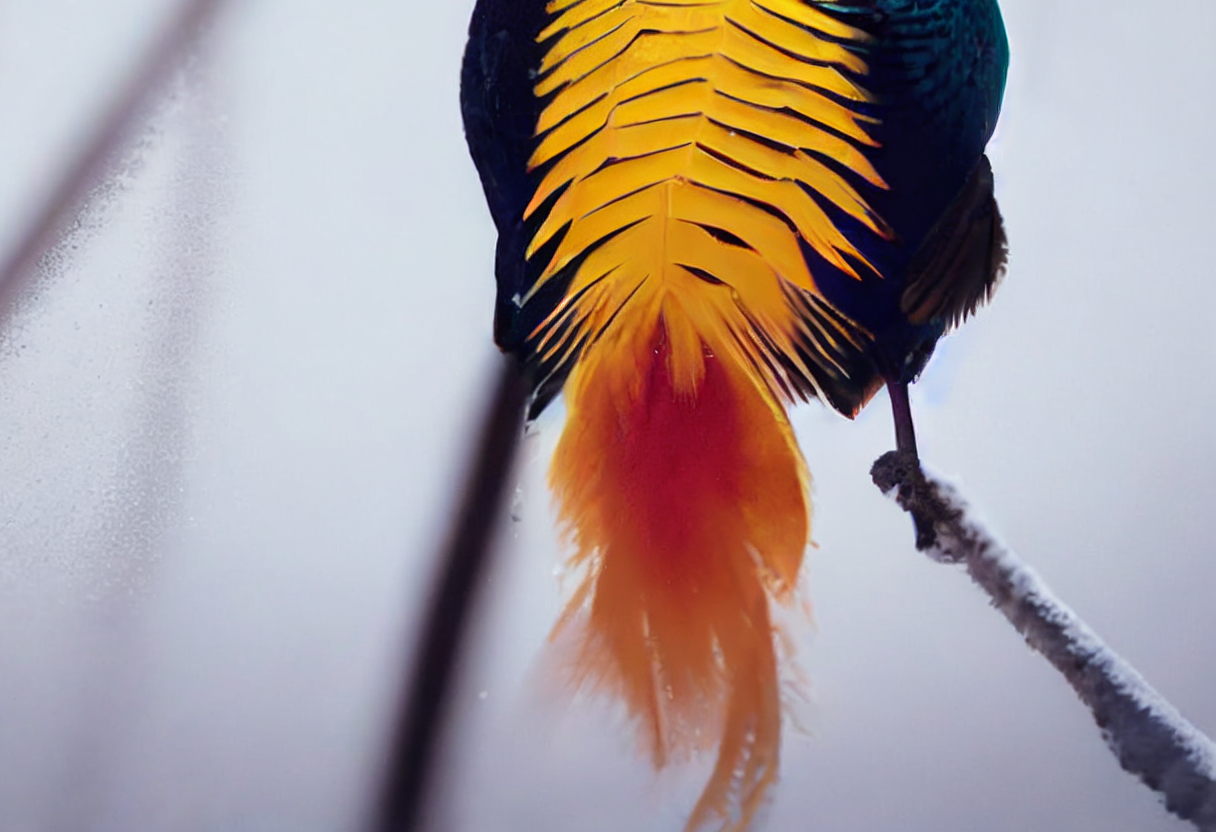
550,309,810,830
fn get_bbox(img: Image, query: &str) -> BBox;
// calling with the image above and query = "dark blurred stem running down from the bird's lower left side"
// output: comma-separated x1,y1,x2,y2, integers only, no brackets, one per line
372,358,528,832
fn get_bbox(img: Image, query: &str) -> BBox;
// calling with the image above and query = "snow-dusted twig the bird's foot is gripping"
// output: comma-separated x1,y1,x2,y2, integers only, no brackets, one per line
871,451,1216,832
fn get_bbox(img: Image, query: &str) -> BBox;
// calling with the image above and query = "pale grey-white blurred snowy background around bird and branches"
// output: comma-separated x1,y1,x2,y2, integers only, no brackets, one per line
0,0,1216,832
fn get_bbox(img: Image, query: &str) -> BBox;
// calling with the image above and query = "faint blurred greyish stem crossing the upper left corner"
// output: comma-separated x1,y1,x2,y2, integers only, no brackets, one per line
0,0,224,320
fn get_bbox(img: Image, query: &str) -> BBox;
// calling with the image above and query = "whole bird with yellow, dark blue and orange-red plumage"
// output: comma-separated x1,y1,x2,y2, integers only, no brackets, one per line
461,0,1009,832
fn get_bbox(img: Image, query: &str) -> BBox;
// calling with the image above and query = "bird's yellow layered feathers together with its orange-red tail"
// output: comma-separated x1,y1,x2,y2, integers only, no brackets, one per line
523,9,886,832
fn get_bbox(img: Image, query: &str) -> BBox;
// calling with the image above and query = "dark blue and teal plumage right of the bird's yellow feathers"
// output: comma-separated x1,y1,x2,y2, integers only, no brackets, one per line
816,0,1009,382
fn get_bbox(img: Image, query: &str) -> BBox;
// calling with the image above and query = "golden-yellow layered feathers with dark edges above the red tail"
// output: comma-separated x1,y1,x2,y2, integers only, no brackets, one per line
524,0,885,403
